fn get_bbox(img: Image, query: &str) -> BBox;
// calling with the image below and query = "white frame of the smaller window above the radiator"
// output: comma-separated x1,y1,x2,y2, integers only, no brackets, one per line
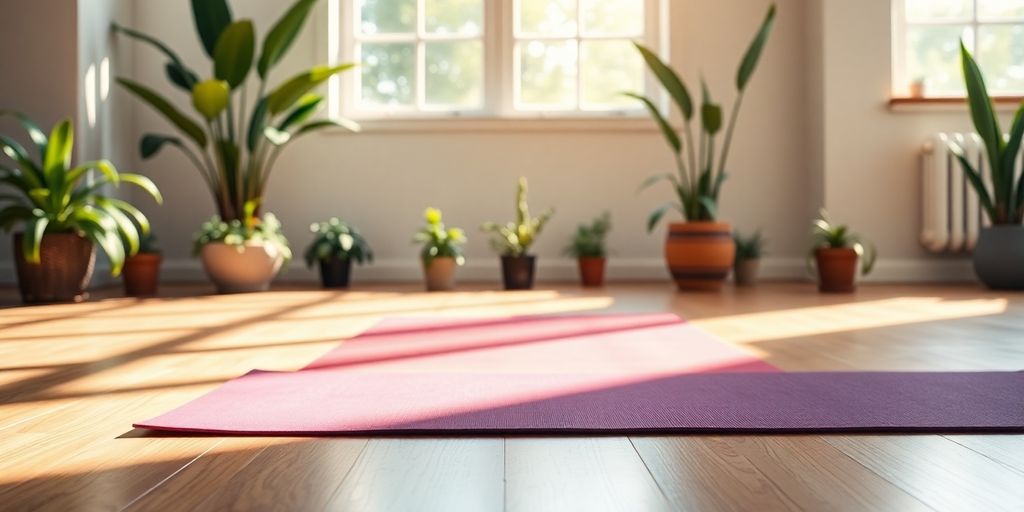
892,0,1024,99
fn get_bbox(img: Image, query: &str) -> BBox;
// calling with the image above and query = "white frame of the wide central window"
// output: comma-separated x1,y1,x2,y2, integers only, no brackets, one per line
317,0,669,122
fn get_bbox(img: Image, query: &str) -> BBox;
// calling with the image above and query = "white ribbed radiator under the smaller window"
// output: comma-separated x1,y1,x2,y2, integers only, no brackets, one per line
921,133,988,253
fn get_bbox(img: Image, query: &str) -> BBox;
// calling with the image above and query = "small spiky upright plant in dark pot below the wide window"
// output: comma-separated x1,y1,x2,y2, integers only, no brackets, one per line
480,178,554,290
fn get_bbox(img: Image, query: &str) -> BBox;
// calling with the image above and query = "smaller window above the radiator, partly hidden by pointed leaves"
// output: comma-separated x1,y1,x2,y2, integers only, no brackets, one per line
893,0,1024,97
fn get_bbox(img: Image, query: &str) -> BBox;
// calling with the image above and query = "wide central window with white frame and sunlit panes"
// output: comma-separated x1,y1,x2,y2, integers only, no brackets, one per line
328,0,664,119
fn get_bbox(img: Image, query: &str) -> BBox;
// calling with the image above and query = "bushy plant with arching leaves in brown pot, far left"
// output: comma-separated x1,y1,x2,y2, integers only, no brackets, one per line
0,111,163,303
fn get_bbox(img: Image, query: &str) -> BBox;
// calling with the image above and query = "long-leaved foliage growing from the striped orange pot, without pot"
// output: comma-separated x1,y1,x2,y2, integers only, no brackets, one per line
627,5,775,231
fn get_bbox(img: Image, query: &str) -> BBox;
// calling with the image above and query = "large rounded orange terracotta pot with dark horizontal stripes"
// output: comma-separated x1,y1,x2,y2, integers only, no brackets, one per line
665,222,736,292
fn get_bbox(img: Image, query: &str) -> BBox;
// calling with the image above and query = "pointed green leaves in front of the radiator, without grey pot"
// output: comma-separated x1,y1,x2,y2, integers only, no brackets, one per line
949,42,1024,224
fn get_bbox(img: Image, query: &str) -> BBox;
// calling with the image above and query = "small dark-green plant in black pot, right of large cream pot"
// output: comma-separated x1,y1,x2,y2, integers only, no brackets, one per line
305,217,374,289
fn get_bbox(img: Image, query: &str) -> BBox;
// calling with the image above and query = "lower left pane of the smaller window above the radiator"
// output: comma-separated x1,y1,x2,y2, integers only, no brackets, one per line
906,26,971,95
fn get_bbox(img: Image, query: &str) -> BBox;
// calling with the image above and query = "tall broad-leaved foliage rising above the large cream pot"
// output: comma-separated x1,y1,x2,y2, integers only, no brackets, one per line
114,0,358,223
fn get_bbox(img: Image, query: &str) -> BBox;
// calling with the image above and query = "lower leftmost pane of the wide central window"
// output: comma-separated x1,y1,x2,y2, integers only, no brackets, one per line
359,43,416,105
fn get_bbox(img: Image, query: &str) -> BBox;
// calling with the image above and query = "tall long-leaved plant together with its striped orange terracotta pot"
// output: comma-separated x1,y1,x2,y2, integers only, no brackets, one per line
628,5,775,291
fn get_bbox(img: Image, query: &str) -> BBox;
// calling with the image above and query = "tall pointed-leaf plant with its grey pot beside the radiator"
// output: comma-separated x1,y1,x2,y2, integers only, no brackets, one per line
950,44,1024,290
